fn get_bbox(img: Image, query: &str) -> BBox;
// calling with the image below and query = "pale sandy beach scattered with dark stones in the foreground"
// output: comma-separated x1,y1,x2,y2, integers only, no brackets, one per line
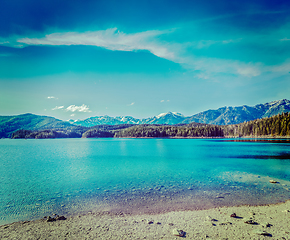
0,201,290,239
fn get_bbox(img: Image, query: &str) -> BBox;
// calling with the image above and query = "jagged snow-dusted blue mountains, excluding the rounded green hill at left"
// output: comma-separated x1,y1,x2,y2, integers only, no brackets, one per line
69,99,290,127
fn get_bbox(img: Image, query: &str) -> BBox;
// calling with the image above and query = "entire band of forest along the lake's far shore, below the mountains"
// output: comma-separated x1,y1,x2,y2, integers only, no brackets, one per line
12,113,290,138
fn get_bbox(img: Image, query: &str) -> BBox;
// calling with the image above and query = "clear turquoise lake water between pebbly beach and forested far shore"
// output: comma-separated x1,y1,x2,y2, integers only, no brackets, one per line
0,139,290,224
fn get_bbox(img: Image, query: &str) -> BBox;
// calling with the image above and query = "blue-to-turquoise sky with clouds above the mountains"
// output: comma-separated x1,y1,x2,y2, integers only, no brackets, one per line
0,0,290,120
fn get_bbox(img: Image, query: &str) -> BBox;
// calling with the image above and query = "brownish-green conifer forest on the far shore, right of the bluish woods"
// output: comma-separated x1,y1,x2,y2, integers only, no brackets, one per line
115,113,290,137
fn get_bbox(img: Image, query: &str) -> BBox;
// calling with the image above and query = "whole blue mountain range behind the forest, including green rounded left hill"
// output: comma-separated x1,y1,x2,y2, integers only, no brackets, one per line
0,99,290,138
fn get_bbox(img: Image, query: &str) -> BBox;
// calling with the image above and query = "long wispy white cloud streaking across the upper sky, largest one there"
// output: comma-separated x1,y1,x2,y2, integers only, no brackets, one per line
11,28,280,78
